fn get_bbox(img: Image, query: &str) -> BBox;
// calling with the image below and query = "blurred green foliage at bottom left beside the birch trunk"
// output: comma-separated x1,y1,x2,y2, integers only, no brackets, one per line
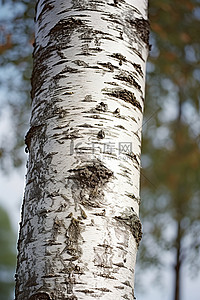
0,207,16,300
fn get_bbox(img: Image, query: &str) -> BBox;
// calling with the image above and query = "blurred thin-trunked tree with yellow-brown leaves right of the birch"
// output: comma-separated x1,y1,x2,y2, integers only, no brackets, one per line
140,0,200,300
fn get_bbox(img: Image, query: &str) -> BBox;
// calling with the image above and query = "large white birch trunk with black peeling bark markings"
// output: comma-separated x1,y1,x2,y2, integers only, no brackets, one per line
15,0,149,300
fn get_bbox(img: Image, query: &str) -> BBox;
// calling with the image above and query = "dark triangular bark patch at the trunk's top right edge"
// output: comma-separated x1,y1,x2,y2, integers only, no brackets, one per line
129,18,150,46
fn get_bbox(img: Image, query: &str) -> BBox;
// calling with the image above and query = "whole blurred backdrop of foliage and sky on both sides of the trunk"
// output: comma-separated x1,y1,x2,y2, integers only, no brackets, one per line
0,0,200,300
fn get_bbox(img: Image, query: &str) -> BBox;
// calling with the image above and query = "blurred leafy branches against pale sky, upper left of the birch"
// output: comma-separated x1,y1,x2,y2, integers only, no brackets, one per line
0,0,35,172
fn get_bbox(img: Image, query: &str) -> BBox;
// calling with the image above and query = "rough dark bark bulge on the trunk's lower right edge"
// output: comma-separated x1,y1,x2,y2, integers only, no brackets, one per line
114,207,142,247
